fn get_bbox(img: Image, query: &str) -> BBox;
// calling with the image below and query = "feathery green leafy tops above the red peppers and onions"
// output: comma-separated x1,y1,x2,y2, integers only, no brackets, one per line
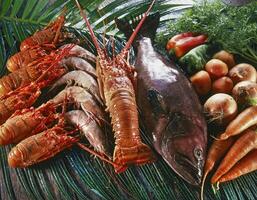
157,0,257,64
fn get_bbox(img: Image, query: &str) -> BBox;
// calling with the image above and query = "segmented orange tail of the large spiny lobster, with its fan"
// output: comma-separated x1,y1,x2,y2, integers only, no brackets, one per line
109,89,154,173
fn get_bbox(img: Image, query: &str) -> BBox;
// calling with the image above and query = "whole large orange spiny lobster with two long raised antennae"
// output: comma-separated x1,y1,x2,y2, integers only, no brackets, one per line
76,0,155,173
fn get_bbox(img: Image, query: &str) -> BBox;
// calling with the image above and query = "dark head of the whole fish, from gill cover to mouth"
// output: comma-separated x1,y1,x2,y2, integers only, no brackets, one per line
160,112,206,185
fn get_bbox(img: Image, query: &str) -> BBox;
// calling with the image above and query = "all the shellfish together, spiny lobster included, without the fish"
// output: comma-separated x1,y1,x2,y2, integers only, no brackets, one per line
0,0,158,173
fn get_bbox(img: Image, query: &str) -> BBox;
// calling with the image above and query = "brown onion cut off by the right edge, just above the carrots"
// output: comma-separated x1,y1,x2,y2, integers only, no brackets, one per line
232,81,257,107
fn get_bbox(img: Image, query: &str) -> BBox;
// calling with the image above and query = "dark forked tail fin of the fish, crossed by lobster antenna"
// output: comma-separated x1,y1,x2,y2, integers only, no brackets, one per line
115,12,160,48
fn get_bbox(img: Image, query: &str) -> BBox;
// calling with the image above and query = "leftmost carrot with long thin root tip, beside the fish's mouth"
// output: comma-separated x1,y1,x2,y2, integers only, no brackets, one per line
201,137,235,199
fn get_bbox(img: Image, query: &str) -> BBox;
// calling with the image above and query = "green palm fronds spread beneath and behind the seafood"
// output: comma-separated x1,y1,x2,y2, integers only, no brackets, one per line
0,0,257,200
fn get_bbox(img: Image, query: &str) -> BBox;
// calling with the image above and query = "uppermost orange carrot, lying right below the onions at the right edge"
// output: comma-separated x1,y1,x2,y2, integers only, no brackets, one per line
219,106,257,140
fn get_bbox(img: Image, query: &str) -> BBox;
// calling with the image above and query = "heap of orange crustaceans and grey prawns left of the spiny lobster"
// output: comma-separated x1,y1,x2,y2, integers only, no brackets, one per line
0,13,115,167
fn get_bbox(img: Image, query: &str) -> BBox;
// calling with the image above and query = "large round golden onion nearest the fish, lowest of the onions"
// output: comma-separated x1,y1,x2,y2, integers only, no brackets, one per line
204,93,237,126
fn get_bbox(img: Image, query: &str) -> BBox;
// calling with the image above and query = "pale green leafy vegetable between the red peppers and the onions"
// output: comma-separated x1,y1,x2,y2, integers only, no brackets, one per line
179,44,209,74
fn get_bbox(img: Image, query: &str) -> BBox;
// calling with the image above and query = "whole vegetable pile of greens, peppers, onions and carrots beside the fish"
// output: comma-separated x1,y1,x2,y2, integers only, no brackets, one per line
158,1,257,196
